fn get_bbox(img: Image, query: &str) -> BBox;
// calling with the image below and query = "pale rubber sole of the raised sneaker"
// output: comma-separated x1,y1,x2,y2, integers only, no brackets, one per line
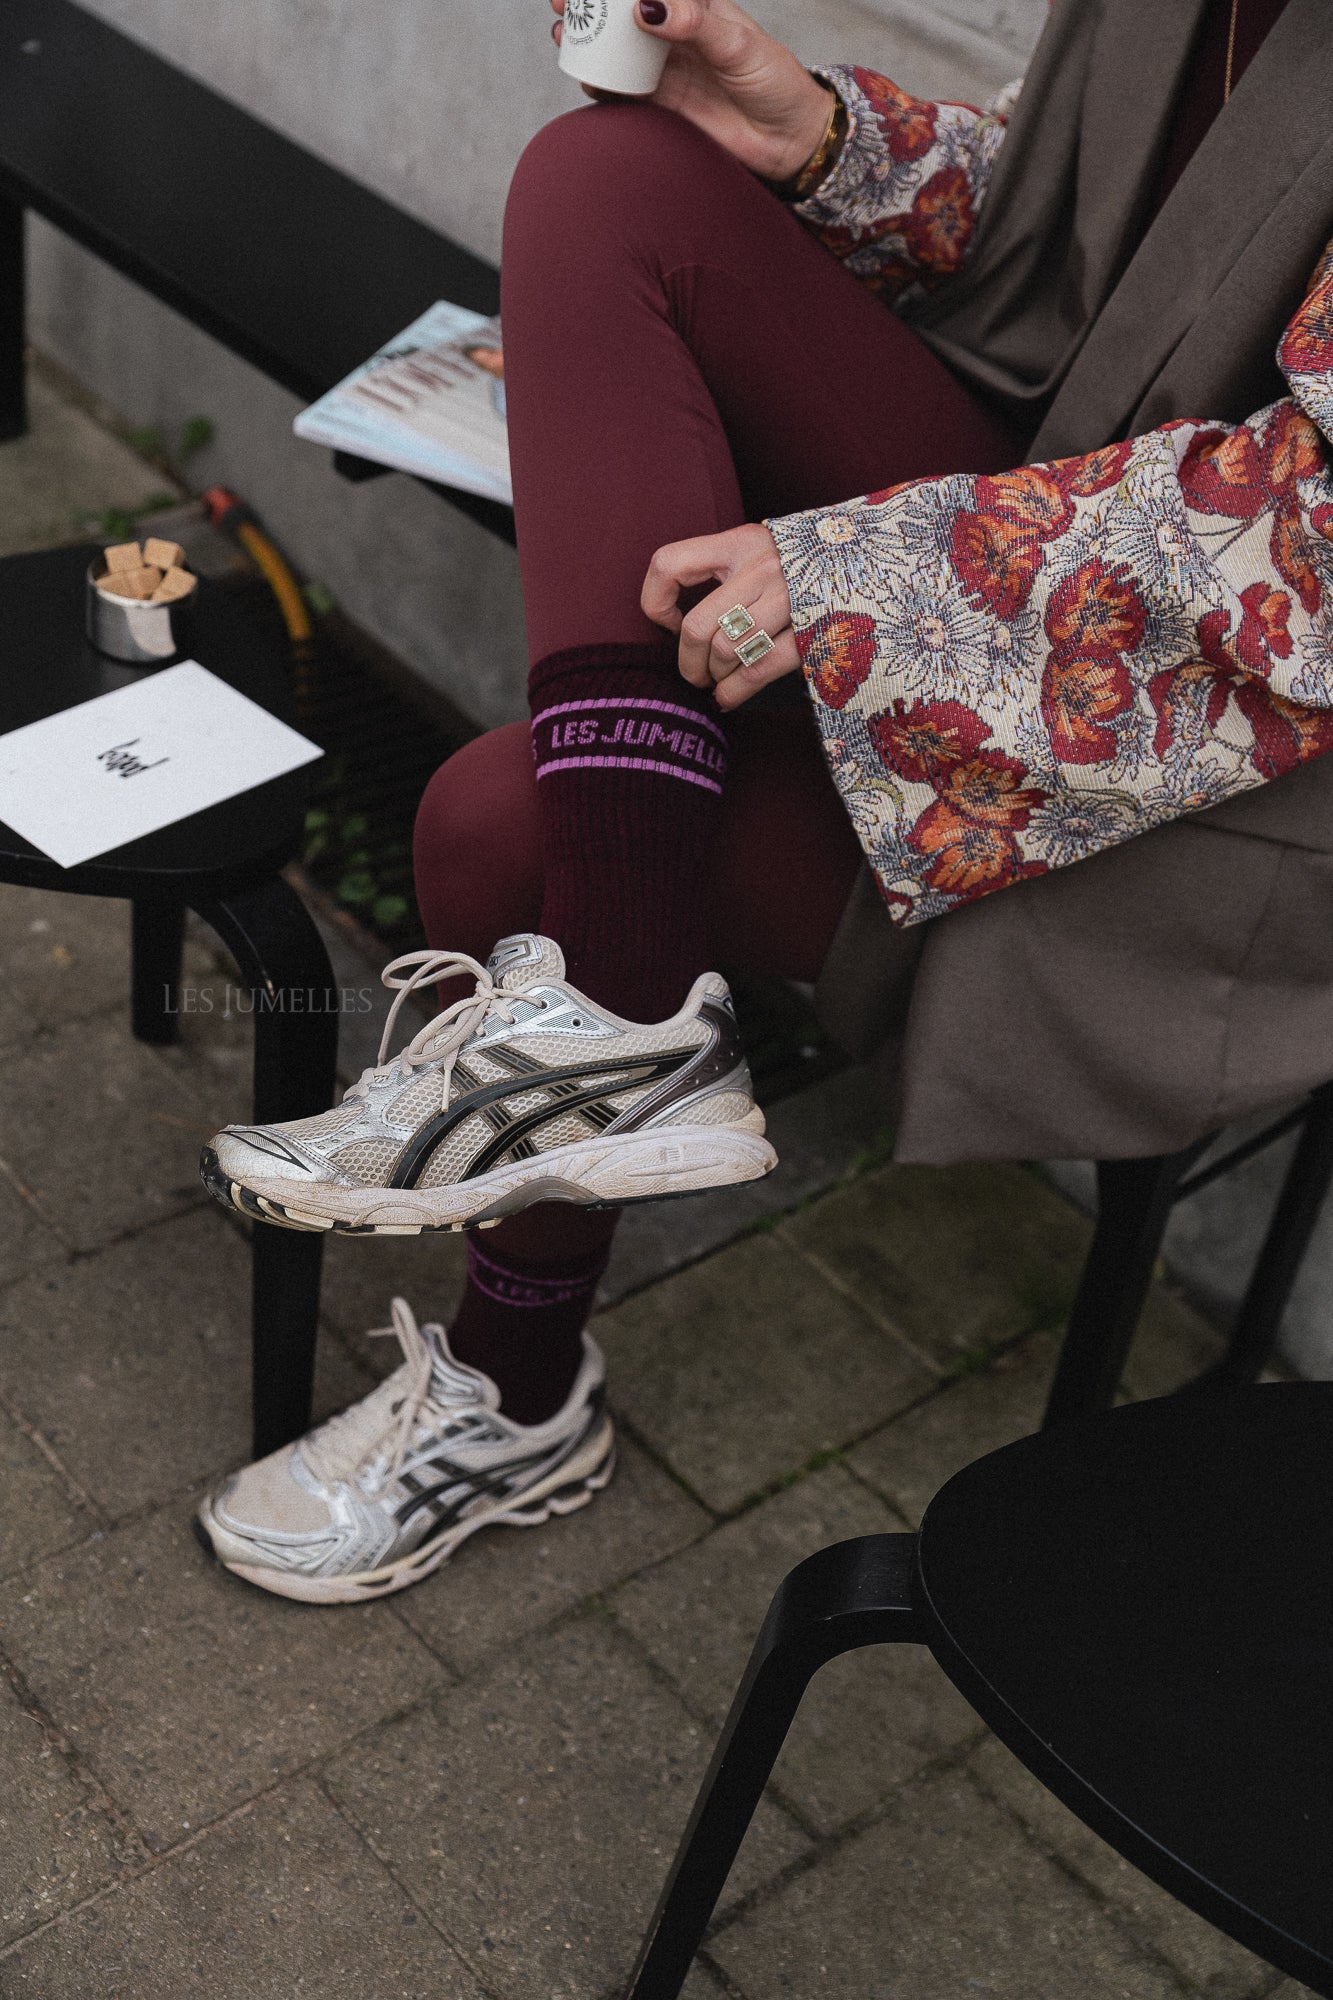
200,1114,777,1236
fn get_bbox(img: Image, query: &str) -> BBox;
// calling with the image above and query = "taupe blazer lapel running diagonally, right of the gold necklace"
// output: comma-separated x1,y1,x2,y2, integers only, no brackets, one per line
1031,0,1333,460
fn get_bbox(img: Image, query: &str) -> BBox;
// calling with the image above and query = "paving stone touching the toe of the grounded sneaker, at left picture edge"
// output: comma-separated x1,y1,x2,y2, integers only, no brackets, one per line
0,1506,442,1850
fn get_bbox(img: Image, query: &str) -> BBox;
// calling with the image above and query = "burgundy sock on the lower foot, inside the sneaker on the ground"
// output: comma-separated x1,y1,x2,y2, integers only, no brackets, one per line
448,1202,618,1424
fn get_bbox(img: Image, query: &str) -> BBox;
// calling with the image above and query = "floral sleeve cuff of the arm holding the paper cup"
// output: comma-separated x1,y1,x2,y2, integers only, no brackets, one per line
797,66,1005,302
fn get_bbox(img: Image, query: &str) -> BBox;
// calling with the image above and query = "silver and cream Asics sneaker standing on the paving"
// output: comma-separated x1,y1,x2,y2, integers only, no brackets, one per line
196,1298,614,1604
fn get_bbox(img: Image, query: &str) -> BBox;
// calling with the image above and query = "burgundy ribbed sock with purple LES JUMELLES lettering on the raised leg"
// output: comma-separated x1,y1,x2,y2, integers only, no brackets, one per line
528,644,727,1022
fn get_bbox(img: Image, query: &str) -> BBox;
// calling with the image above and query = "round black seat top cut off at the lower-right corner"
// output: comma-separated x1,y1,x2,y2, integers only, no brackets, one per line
917,1382,1333,1994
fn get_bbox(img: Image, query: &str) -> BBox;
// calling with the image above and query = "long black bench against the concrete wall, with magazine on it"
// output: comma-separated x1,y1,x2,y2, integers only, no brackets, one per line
0,0,512,540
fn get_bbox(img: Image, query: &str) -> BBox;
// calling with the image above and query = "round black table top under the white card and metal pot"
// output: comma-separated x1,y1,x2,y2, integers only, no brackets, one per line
0,548,306,900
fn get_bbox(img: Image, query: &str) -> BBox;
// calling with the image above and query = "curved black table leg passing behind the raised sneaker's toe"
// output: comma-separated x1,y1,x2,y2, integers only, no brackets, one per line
198,876,338,1458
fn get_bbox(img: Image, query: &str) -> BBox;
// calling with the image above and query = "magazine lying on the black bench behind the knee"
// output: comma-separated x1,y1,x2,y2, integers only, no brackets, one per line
294,302,514,504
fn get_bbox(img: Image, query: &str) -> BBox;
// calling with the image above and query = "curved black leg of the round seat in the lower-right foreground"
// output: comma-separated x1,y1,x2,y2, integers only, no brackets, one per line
628,1534,925,2000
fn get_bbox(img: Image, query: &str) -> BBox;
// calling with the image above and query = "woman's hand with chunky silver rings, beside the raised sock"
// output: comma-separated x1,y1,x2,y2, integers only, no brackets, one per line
640,528,801,708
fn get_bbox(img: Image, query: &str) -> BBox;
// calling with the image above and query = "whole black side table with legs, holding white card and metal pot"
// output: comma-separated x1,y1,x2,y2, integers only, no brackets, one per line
0,548,338,1456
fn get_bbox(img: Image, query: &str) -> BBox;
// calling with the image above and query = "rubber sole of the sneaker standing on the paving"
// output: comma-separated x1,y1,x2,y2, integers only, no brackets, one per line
194,1418,616,1604
